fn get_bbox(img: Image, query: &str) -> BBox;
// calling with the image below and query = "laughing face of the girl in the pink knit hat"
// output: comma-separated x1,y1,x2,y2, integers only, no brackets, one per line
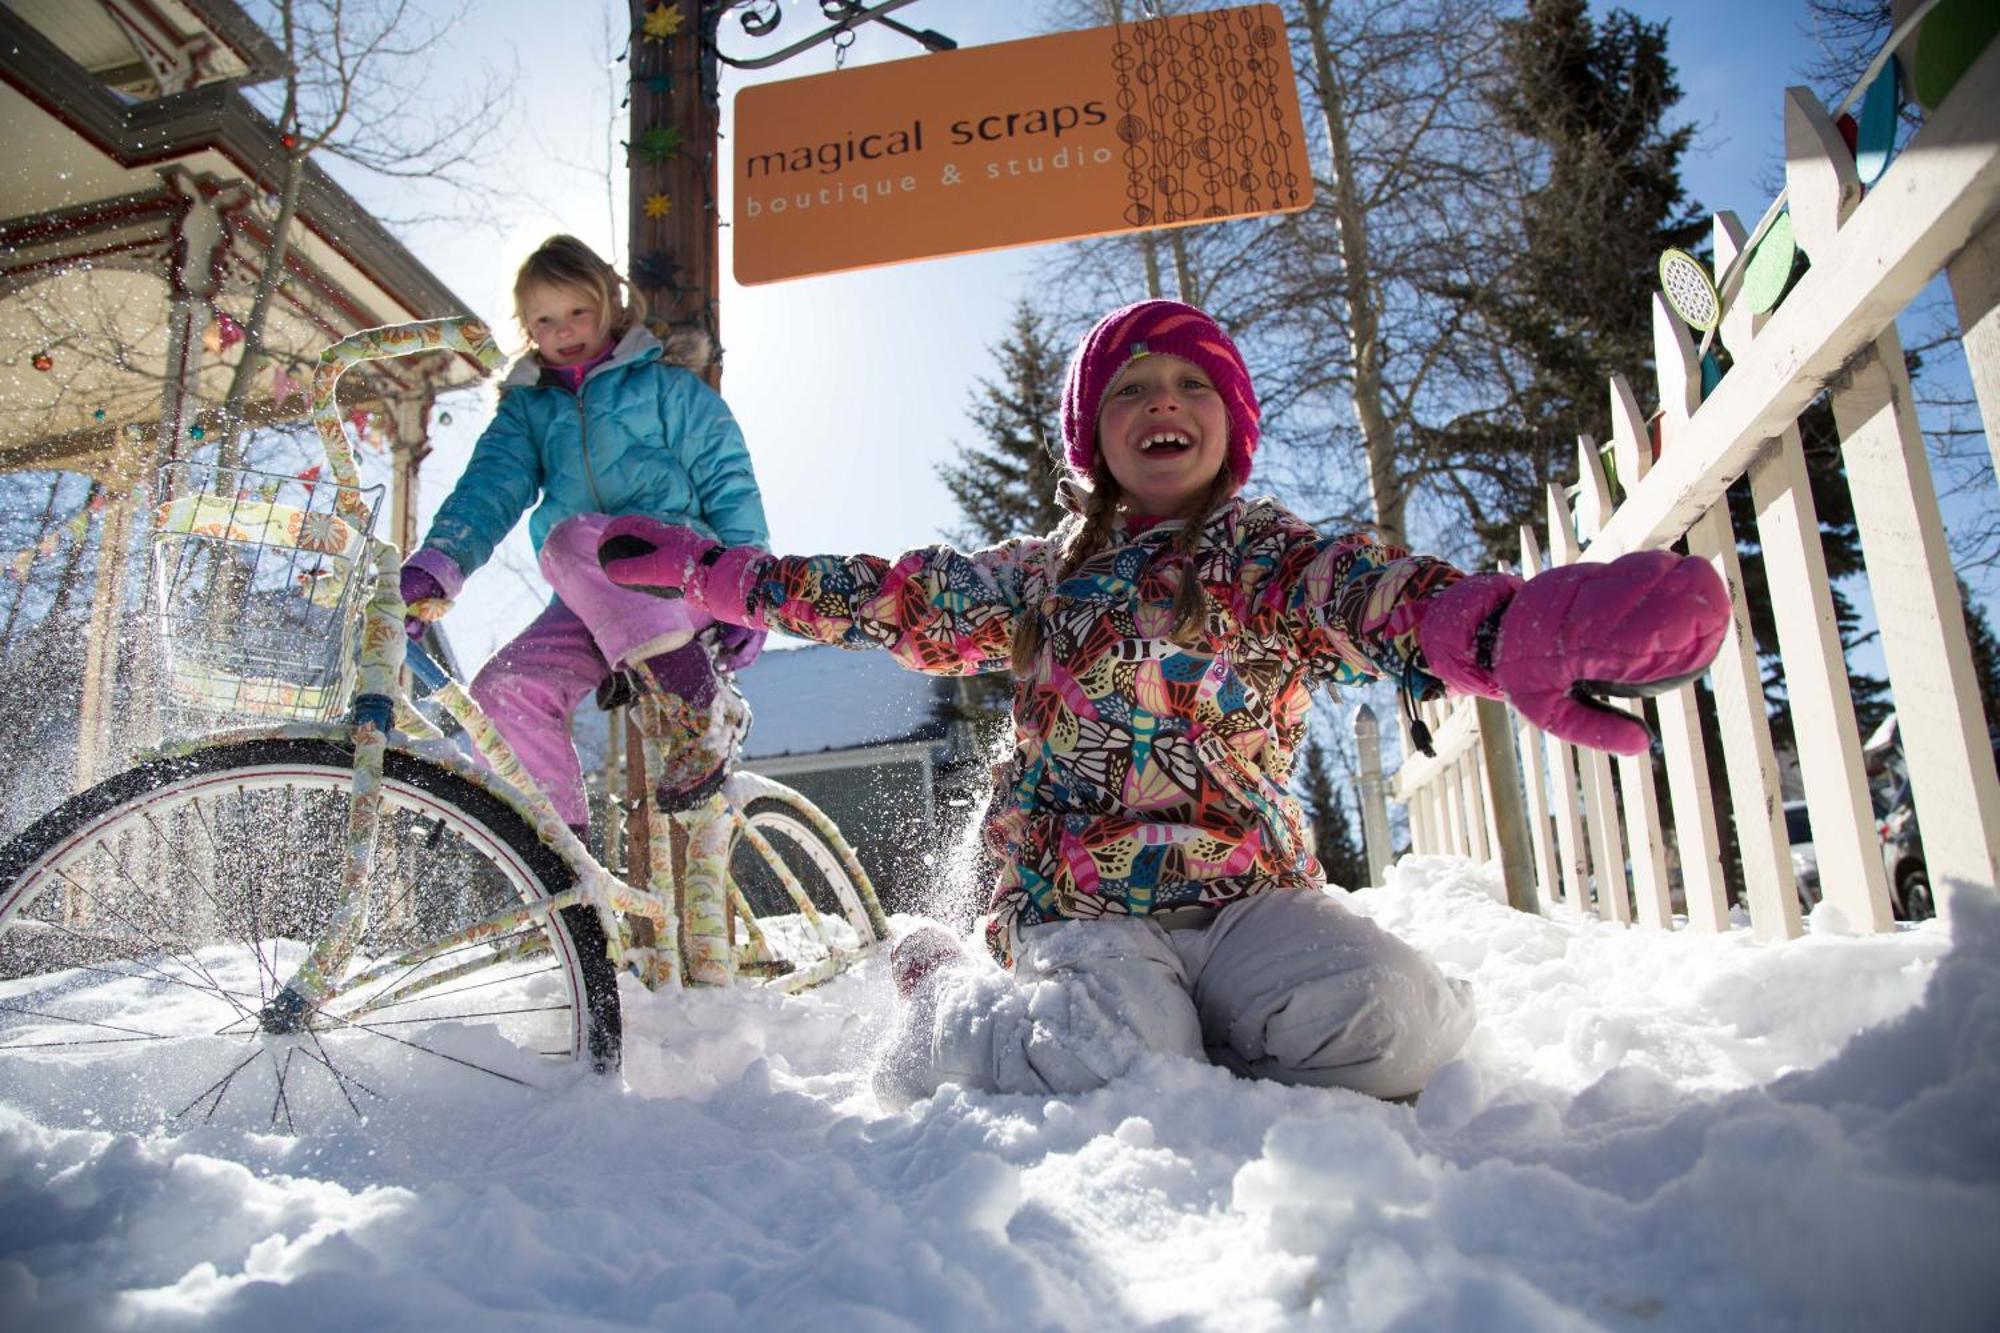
1098,352,1230,518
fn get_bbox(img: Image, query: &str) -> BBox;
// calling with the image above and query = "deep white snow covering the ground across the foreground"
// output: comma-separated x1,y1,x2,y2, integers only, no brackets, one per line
0,857,2000,1333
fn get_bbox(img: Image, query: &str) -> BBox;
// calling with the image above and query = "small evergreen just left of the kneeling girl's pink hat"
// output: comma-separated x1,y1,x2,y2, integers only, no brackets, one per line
938,298,1066,546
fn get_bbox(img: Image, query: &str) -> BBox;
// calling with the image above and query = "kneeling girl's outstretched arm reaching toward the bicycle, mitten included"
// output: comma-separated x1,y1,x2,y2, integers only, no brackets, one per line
598,514,1040,677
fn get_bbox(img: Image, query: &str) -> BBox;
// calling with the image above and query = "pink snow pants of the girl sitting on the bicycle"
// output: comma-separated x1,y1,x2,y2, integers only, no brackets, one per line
472,514,716,827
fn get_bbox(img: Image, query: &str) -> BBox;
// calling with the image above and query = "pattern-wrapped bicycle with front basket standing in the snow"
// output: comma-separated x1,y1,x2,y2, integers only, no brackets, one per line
0,318,888,1129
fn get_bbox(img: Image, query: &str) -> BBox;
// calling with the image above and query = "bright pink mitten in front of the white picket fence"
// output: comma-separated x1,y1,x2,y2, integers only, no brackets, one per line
1418,550,1730,755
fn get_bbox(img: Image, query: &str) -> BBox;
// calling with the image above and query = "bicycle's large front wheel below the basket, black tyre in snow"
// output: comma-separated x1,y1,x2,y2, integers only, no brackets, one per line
0,739,620,1129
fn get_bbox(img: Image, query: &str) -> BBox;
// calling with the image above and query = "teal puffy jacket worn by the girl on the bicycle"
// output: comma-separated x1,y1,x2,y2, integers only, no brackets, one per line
424,328,770,574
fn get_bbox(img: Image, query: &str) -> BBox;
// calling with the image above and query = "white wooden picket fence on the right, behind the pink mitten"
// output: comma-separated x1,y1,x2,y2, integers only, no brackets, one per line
1362,42,2000,939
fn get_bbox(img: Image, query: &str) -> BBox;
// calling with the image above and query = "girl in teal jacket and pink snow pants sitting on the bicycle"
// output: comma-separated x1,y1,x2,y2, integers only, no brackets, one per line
402,236,768,835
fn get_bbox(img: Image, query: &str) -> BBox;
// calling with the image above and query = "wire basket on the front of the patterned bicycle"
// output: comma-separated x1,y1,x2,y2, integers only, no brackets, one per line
152,462,384,735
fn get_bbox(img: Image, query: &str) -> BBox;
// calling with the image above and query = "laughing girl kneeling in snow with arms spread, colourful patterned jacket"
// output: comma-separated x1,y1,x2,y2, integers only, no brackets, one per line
584,300,1728,1099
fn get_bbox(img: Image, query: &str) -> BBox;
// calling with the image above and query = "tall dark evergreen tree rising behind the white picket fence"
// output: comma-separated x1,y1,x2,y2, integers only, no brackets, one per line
1438,0,1704,560
